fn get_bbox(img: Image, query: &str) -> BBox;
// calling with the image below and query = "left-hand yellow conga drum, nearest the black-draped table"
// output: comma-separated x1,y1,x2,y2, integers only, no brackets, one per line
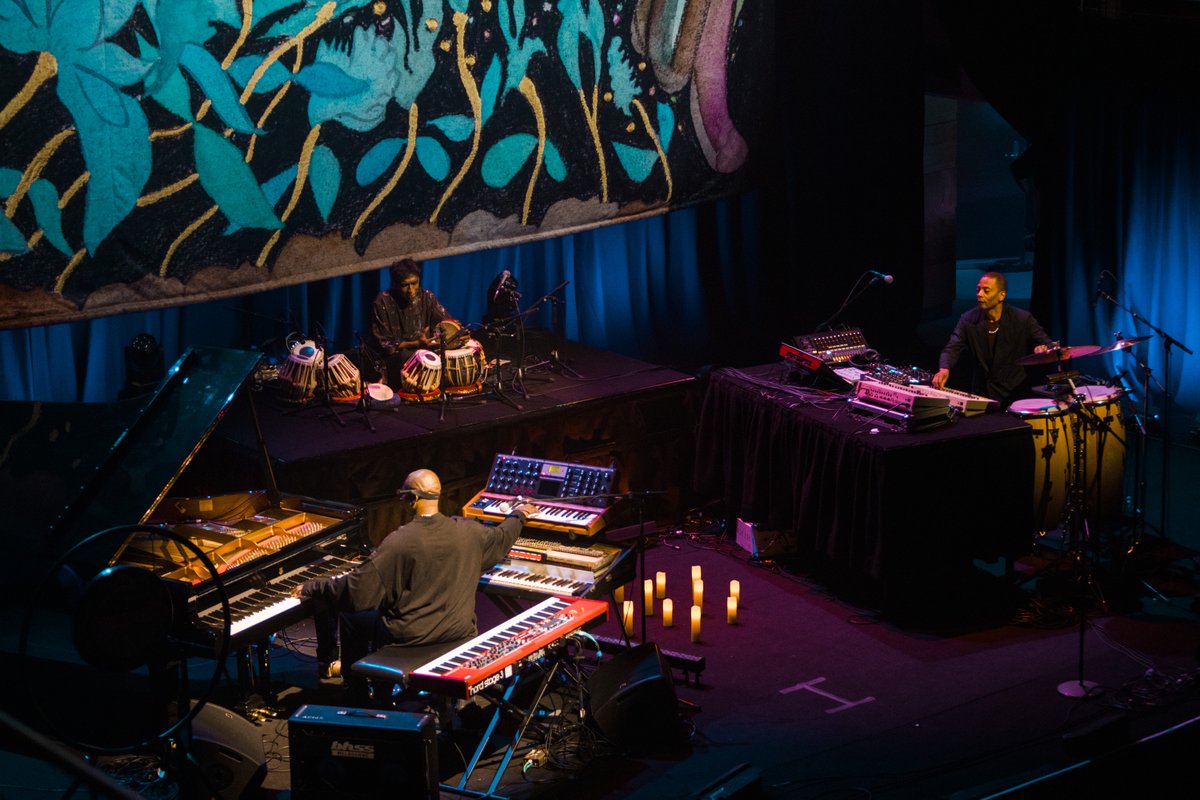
1008,397,1074,531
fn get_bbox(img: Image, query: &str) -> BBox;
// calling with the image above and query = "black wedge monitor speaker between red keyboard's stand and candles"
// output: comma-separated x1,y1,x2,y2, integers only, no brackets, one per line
588,642,682,751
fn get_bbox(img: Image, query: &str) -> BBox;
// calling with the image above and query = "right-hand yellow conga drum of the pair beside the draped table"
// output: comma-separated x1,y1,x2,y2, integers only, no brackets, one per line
1075,386,1126,522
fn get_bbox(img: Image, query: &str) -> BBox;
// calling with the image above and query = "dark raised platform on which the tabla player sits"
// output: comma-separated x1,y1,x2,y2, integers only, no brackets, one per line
182,331,698,542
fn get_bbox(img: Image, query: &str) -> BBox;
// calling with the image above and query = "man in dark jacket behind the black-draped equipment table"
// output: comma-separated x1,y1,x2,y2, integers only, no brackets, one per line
932,272,1052,408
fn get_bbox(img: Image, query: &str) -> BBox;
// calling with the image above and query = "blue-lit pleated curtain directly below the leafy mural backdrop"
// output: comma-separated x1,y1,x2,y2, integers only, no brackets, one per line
0,197,763,402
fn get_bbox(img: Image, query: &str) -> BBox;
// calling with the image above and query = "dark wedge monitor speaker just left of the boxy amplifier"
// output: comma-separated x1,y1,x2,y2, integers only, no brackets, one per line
191,703,266,800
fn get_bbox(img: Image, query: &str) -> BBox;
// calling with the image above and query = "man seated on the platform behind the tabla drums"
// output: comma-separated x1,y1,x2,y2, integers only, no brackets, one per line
371,258,461,389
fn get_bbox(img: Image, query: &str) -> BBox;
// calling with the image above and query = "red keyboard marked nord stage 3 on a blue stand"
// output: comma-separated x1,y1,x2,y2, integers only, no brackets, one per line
408,597,608,699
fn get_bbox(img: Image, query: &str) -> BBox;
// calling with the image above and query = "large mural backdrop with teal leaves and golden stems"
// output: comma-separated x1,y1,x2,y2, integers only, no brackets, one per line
0,0,764,327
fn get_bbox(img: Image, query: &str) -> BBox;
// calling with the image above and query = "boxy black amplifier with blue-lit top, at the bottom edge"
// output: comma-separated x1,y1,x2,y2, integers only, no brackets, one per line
288,705,440,800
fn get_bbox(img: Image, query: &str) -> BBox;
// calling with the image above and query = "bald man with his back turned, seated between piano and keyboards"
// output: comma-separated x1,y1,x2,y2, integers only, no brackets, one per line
294,469,534,705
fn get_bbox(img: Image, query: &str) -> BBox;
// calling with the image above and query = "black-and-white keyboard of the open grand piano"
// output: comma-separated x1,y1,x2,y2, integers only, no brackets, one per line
197,554,358,646
